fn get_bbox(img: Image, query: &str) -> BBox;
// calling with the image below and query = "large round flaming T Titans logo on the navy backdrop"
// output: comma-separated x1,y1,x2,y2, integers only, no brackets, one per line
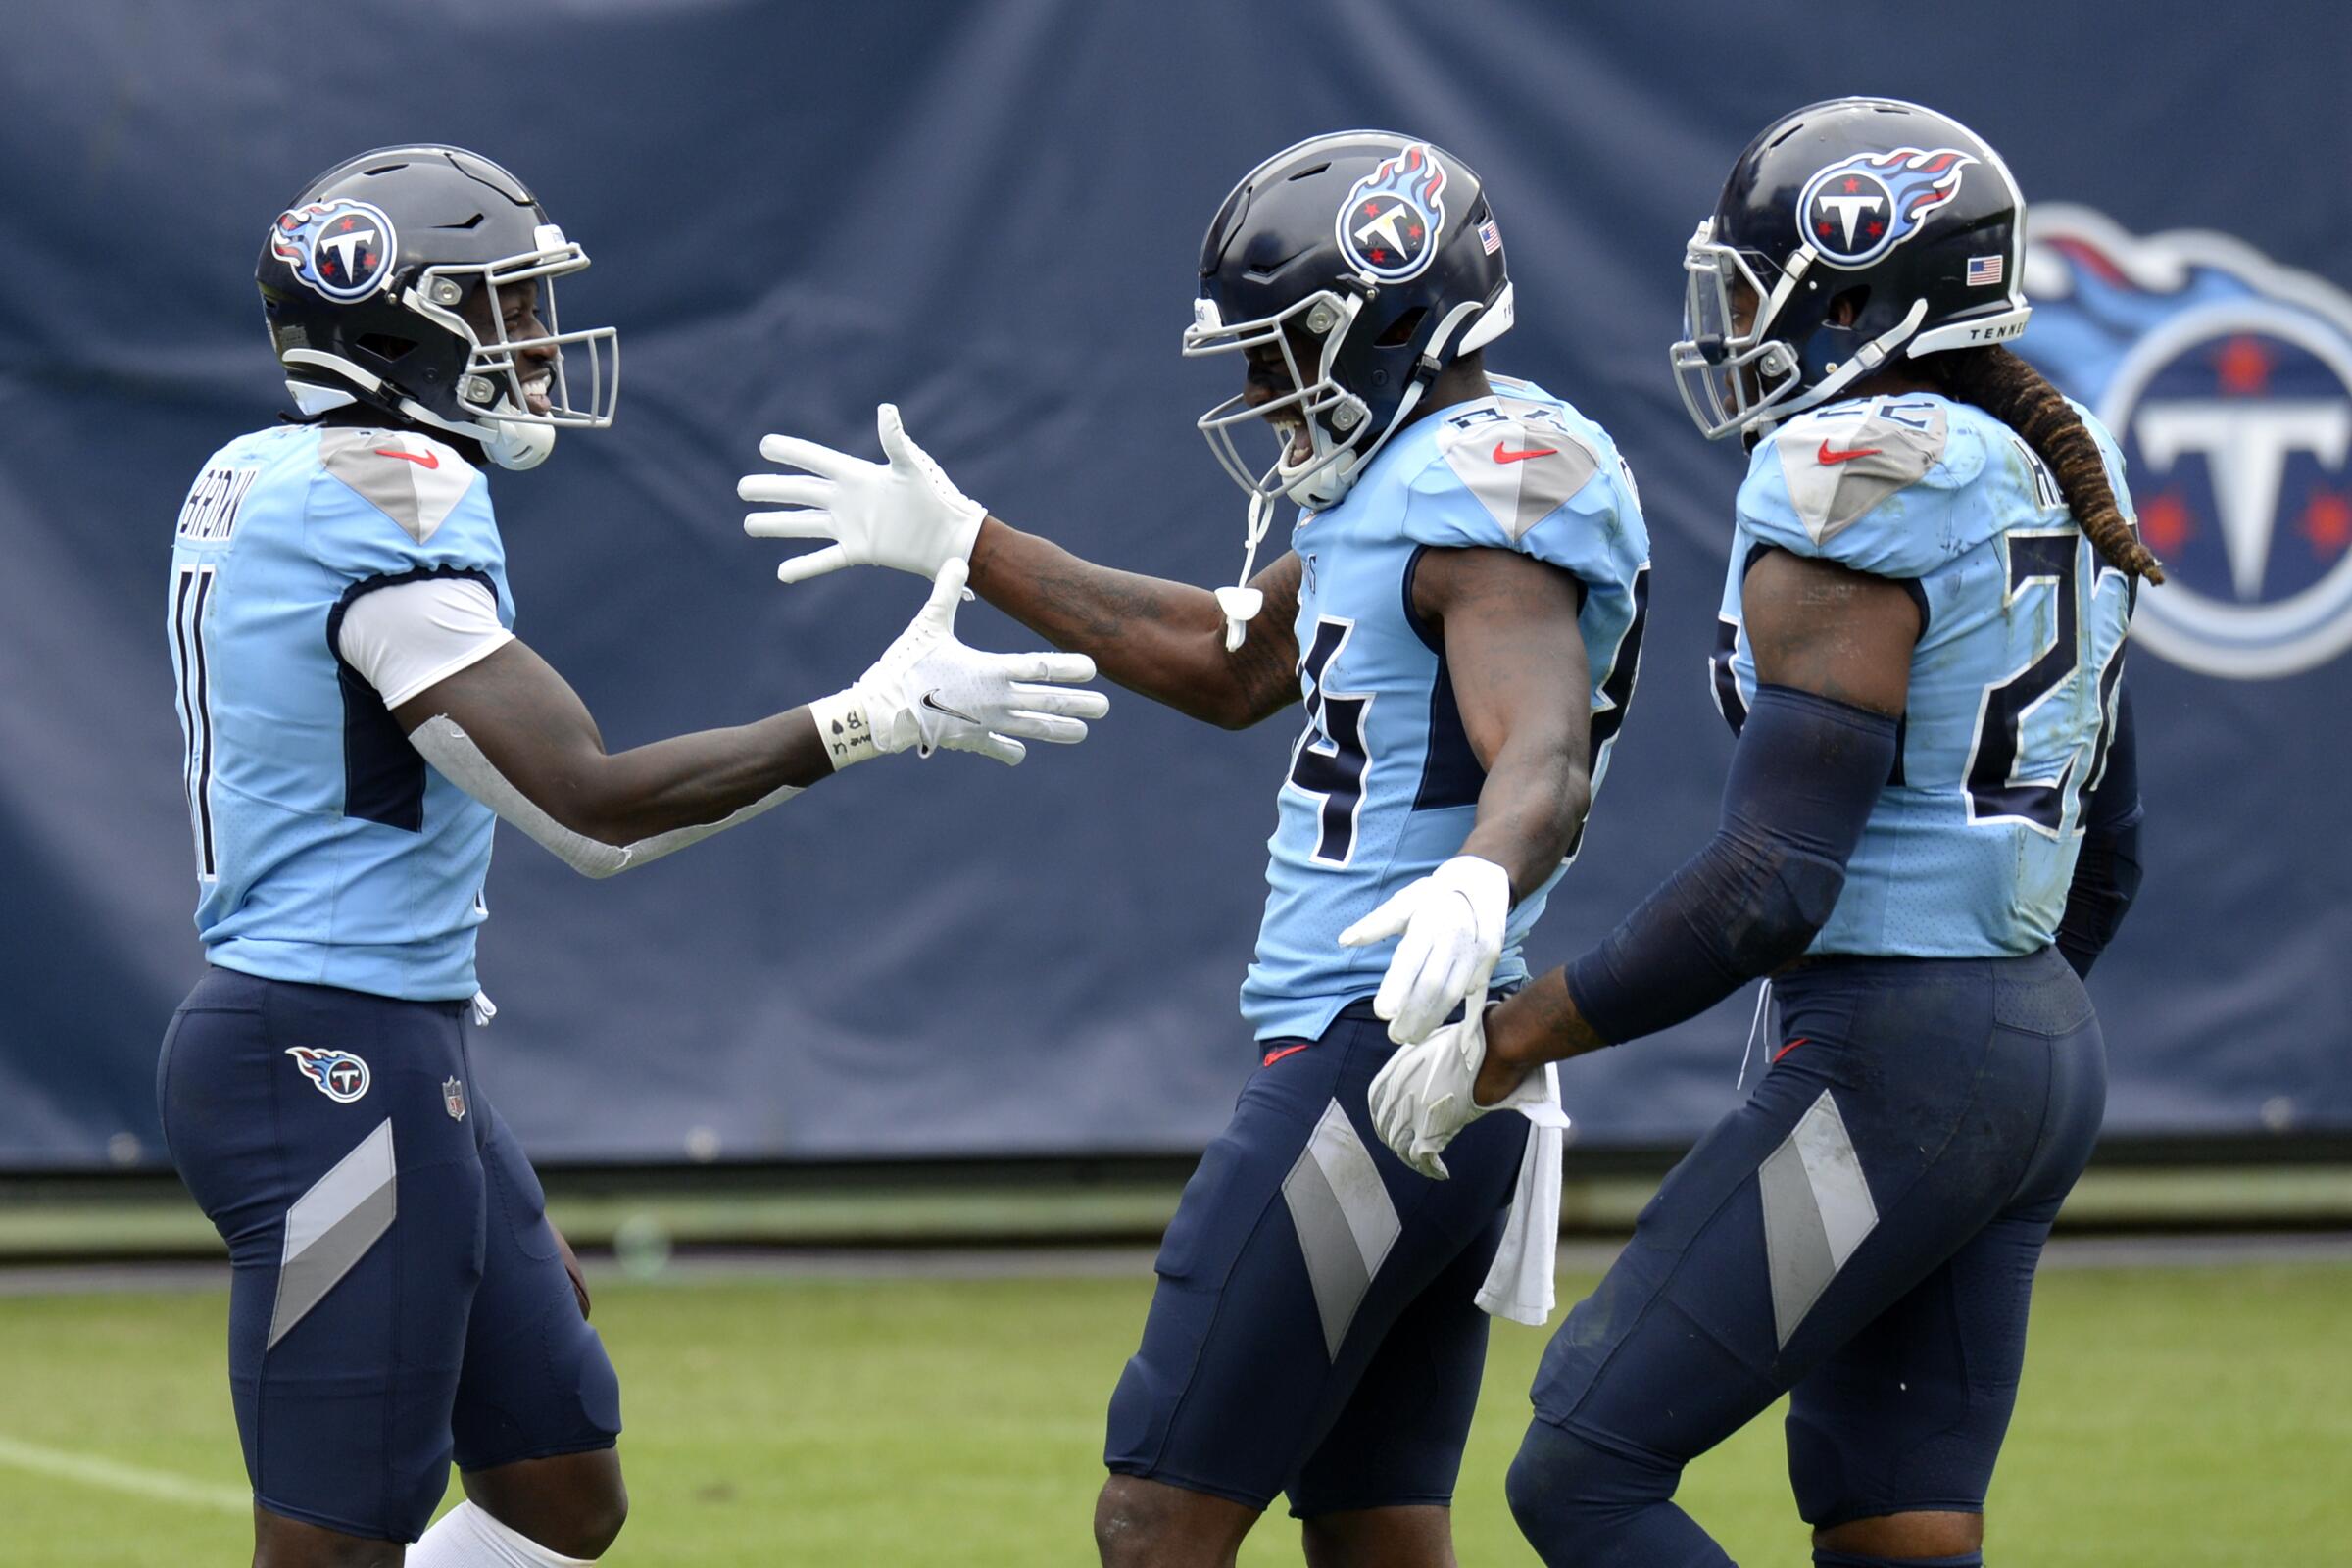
2018,202,2352,679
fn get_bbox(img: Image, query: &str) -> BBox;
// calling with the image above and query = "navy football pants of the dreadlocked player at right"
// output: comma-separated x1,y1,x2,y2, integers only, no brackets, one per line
1510,950,2107,1568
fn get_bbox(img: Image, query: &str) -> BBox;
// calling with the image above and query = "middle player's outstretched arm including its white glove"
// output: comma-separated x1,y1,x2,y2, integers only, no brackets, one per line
736,405,1300,729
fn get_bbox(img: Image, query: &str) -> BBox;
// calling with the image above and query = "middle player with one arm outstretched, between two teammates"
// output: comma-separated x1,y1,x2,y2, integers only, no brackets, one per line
741,131,1648,1566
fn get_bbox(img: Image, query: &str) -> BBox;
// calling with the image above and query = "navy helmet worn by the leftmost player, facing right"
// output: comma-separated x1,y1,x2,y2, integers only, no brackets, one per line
254,143,621,467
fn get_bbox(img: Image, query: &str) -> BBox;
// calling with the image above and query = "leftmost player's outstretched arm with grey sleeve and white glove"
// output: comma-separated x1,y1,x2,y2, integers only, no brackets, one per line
393,562,1110,877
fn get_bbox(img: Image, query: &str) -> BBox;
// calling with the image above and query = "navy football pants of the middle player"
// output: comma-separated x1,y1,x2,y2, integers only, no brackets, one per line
1103,1004,1527,1519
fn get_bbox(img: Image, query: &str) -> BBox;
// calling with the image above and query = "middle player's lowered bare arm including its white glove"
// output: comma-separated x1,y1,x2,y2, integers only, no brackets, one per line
1339,548,1592,1044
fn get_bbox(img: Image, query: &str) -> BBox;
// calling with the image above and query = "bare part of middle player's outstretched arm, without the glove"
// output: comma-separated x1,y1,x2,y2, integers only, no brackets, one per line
971,517,1298,729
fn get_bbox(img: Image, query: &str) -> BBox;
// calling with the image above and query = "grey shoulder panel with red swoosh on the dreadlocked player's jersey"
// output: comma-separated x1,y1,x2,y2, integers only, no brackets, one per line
1750,397,1983,546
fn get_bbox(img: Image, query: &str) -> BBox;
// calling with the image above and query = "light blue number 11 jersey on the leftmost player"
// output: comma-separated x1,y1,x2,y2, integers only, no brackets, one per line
167,425,513,999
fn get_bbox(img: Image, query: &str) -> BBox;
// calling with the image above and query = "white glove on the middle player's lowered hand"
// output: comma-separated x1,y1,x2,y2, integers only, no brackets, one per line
1339,856,1510,1046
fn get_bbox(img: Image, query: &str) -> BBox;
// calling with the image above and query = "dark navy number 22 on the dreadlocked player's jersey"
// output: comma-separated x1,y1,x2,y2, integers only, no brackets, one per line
1969,529,2133,837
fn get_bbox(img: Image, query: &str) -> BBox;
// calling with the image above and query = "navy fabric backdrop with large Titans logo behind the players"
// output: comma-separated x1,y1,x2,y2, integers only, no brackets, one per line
0,0,2352,1168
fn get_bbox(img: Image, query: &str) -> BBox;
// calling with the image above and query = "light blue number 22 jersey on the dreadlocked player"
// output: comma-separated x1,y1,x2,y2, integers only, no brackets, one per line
1715,393,2135,956
